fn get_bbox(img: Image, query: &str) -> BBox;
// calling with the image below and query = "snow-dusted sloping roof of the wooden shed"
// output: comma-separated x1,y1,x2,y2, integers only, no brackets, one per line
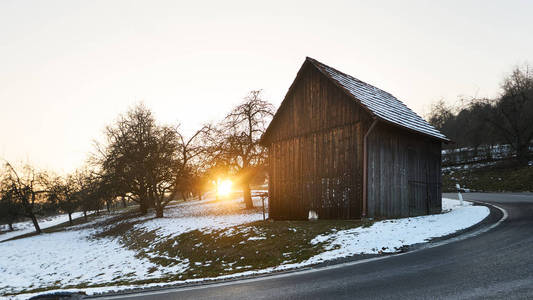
306,57,449,141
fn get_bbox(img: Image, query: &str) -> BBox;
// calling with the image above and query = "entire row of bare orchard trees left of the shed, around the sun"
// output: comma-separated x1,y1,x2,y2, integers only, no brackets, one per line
0,90,274,233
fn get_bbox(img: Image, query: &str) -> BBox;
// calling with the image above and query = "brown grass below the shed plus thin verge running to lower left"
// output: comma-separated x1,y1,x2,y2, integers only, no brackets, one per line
2,199,372,296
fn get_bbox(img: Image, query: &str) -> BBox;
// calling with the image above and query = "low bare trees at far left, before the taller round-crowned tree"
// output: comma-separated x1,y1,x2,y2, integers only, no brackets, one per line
0,162,107,233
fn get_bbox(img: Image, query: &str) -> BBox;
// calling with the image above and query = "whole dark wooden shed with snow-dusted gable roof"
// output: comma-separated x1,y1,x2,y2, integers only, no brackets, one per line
261,58,448,219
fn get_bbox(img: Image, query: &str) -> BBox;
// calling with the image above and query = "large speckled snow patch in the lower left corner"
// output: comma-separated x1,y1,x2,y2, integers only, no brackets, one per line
0,230,188,294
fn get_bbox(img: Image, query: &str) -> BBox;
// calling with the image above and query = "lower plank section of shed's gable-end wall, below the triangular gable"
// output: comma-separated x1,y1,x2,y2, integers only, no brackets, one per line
269,123,362,219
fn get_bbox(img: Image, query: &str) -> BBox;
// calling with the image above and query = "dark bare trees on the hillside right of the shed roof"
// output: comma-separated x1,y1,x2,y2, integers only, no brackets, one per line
429,65,533,164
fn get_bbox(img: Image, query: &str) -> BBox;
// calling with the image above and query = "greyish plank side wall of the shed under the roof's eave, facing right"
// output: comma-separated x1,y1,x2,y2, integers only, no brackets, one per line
368,123,442,217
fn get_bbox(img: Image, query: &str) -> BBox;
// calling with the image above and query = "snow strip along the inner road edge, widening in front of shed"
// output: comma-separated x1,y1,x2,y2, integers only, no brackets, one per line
9,199,490,299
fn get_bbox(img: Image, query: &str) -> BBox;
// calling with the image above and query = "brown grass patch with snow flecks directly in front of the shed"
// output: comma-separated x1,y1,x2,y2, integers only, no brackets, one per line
97,216,369,284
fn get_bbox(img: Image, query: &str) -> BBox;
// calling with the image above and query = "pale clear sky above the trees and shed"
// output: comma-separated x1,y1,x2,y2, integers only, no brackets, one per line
0,0,533,172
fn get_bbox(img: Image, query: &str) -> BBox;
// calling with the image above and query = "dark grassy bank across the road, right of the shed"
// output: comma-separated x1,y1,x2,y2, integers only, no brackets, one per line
442,162,533,192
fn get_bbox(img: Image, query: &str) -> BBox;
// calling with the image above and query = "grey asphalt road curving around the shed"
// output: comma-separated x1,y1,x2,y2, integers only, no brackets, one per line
100,193,533,300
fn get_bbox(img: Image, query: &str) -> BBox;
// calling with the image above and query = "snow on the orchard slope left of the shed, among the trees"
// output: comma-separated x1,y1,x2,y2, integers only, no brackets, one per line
0,191,263,298
